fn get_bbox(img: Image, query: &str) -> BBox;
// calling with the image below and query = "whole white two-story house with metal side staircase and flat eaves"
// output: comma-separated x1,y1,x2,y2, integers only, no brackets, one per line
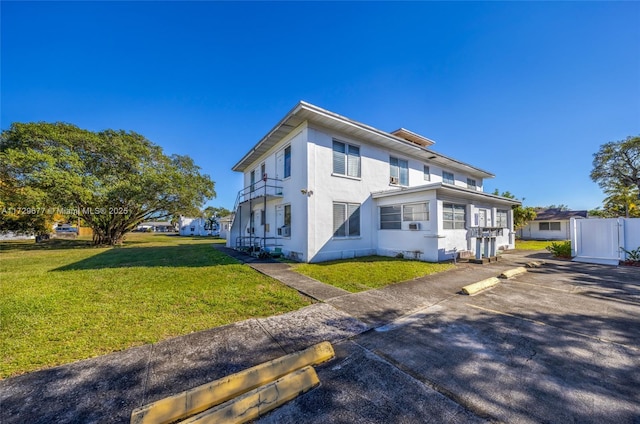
227,102,520,262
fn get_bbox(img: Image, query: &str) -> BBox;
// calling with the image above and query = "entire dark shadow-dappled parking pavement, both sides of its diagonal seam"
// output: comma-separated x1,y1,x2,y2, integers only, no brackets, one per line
260,255,640,424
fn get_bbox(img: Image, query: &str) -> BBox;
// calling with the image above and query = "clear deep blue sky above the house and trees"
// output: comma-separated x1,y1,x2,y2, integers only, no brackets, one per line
0,1,640,209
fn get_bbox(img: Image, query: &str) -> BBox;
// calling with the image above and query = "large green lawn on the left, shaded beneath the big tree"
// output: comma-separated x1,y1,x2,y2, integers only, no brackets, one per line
0,233,311,378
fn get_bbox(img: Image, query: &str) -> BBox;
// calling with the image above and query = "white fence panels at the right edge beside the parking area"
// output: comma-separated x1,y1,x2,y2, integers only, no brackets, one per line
570,218,640,265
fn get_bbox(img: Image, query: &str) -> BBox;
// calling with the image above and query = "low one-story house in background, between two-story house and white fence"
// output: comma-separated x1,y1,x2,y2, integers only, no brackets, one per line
517,208,587,240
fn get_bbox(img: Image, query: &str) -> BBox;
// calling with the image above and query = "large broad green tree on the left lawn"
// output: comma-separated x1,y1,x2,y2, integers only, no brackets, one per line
0,122,215,245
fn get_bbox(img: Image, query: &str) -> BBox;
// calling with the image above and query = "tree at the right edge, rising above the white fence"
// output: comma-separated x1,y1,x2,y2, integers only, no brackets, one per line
591,136,640,198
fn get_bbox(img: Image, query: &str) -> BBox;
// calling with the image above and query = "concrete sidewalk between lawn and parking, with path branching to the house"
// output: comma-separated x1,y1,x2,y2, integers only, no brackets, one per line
0,251,536,424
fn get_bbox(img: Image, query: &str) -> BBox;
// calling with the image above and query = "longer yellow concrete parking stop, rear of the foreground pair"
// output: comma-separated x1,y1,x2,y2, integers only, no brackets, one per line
131,342,335,424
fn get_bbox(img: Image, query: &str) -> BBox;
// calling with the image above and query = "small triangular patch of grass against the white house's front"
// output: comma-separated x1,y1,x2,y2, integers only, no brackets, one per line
292,256,454,293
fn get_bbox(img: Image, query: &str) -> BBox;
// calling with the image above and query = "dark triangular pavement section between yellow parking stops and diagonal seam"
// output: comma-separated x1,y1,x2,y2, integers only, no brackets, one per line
258,341,485,424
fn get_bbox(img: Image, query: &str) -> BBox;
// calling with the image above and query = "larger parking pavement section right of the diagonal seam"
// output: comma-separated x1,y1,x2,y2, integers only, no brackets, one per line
355,264,640,423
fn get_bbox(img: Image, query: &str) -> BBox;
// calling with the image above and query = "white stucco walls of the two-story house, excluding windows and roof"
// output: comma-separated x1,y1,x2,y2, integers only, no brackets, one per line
232,122,512,262
